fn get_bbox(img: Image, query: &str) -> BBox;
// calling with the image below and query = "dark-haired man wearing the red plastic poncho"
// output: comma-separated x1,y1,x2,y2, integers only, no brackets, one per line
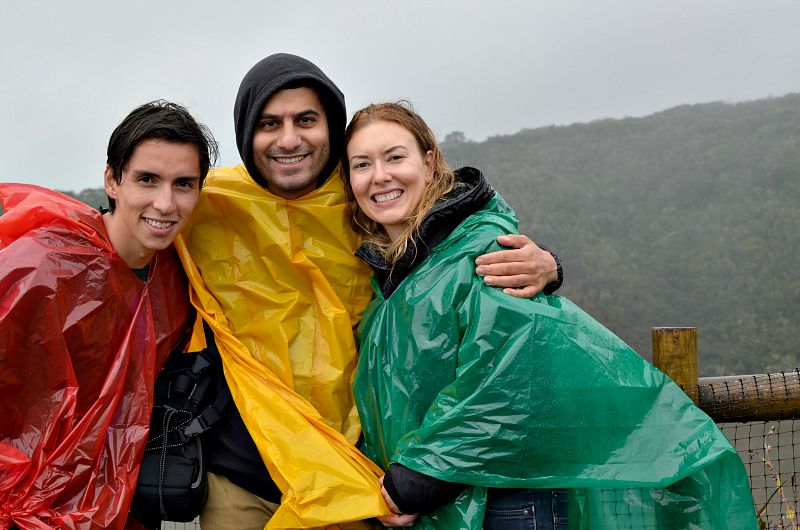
0,101,216,529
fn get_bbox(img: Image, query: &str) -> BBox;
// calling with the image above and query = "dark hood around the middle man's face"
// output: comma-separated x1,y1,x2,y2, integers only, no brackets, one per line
233,53,347,188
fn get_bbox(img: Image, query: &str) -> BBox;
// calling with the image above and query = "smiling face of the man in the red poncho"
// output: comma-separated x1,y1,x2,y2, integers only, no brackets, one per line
103,139,200,269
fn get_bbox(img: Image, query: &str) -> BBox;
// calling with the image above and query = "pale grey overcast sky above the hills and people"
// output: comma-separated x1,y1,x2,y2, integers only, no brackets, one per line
0,0,800,191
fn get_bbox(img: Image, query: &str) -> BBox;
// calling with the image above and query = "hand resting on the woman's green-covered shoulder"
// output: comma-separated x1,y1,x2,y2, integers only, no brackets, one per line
475,234,558,298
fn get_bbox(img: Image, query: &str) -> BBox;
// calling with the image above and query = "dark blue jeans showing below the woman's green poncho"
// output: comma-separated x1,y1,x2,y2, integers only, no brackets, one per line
483,489,567,530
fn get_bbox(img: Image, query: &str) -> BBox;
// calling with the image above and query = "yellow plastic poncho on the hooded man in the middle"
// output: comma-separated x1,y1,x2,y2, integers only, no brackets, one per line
175,165,389,528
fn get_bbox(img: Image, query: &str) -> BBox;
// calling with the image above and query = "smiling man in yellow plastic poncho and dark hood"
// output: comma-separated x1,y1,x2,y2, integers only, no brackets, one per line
176,50,558,530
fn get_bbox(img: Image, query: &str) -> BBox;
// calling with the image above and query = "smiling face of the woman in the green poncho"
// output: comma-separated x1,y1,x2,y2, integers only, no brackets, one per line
347,121,433,241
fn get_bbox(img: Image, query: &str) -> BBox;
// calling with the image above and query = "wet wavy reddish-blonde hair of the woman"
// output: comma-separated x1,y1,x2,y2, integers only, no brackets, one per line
342,101,455,265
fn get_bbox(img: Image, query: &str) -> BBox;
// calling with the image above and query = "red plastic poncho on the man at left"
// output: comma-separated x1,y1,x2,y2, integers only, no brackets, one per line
0,184,192,529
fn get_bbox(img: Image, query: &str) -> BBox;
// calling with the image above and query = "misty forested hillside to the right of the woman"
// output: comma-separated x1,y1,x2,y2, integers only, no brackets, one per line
444,94,800,375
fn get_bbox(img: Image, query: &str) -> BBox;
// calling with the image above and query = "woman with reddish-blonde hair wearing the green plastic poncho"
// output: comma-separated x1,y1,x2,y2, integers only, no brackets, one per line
344,100,756,530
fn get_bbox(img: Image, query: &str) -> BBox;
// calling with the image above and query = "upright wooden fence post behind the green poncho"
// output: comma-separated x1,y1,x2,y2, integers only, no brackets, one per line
652,328,697,403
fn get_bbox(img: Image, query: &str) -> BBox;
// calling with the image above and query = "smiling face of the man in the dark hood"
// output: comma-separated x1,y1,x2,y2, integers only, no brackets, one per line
253,87,330,199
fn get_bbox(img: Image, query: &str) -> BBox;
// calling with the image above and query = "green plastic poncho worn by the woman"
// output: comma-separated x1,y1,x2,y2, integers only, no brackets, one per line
355,197,756,530
